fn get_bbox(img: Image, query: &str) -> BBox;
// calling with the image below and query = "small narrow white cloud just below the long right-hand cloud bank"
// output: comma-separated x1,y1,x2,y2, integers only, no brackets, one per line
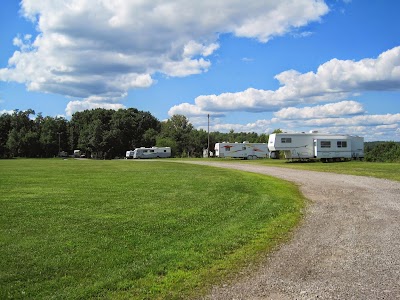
274,101,365,119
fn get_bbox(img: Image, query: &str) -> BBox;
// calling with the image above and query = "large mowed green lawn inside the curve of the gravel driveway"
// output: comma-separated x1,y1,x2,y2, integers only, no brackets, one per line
0,159,304,299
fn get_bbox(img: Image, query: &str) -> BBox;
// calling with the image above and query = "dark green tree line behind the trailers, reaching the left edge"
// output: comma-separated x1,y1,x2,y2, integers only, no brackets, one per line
0,108,268,159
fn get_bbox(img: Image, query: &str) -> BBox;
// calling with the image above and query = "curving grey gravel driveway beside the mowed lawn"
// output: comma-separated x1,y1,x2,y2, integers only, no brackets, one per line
178,162,400,300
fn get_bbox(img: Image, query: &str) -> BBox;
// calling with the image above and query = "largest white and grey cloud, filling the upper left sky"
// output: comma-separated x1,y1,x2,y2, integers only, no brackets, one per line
0,0,328,110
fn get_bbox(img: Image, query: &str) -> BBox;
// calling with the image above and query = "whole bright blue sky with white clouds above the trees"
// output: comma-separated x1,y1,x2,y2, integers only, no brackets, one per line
0,0,400,141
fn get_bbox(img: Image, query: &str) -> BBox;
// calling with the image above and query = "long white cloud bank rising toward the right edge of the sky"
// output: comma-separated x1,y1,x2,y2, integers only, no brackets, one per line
175,46,400,112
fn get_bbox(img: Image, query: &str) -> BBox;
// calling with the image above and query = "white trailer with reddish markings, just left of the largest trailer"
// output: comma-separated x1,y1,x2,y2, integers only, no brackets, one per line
214,142,268,159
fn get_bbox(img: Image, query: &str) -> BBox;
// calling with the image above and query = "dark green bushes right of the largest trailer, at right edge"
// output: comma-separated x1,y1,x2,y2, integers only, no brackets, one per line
364,142,400,162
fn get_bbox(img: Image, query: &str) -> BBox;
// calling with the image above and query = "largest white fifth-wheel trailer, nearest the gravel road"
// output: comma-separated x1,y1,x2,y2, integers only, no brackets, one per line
268,131,364,162
